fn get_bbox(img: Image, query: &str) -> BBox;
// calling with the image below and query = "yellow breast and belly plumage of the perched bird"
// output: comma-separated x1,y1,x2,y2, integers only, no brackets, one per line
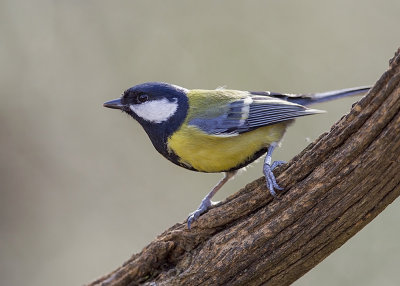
168,122,288,173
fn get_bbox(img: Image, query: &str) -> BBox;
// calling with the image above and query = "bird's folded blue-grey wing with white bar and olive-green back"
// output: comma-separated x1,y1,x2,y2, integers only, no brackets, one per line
188,90,322,136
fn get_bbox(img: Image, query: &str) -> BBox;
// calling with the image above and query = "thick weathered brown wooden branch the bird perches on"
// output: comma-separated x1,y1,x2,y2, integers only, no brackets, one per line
89,49,400,286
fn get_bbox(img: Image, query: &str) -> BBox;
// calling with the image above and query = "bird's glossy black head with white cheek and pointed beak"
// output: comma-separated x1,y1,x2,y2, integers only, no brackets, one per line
104,82,188,144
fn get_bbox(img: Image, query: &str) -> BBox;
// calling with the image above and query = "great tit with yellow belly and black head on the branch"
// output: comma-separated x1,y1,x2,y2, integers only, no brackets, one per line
104,82,369,229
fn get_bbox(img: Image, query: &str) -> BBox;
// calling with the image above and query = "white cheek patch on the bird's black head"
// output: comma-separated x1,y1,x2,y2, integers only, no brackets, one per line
129,98,178,123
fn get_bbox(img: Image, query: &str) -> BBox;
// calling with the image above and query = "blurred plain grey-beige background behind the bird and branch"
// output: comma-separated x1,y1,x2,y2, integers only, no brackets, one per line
0,0,400,286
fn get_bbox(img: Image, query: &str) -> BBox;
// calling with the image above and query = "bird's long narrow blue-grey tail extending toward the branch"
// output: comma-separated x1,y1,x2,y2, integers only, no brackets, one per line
282,86,371,105
